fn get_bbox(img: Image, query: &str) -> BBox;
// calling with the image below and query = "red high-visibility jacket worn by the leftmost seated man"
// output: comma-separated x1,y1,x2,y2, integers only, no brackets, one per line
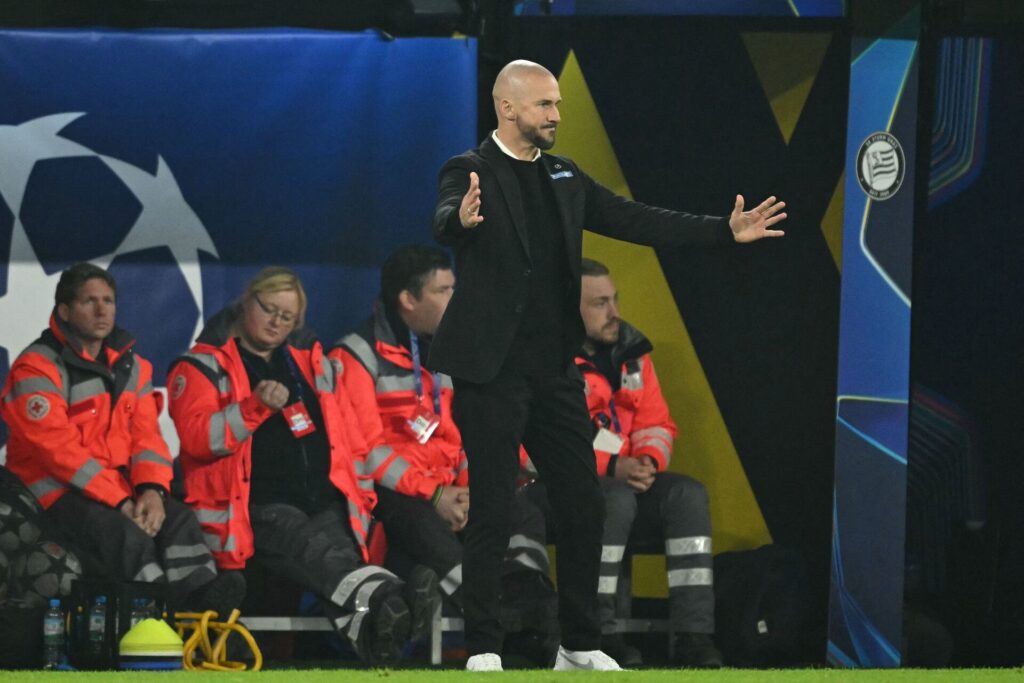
0,315,172,508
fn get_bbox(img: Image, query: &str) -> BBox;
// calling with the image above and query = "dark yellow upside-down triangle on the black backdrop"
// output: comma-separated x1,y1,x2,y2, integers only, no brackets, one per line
742,33,831,144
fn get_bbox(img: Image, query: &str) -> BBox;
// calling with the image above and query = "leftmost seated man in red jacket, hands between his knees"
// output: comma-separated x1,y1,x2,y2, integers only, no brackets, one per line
0,263,239,615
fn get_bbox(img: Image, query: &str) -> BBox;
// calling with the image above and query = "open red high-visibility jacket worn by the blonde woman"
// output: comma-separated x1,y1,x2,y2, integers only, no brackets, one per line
168,306,377,569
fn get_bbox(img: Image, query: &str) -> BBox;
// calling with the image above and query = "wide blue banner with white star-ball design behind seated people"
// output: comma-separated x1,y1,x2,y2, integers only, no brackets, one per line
0,30,476,456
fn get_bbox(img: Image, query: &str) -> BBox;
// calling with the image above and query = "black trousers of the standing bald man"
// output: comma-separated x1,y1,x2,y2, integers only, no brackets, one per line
453,368,604,655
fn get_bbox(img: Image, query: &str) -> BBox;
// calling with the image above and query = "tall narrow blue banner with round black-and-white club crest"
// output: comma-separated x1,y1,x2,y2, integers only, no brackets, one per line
827,29,918,667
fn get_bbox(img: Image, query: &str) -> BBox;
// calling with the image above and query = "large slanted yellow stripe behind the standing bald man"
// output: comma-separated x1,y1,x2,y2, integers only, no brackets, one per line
553,52,771,561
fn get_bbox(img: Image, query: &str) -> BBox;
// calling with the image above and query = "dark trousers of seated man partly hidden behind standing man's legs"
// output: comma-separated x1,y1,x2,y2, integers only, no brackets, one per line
374,486,549,609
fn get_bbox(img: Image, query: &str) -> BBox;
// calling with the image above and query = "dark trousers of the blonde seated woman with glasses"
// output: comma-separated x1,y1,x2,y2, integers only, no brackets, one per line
249,503,401,657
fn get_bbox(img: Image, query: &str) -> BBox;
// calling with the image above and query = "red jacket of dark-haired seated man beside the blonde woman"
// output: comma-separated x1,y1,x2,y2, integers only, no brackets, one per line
330,304,468,500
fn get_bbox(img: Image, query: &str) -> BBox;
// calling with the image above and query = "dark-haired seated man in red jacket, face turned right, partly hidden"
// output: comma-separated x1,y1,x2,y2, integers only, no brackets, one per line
331,245,548,631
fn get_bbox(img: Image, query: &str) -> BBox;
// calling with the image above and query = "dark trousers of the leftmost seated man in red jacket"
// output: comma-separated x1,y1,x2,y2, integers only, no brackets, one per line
46,490,217,609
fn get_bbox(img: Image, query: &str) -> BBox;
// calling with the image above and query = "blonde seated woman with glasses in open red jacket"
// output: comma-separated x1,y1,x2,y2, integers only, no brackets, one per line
168,267,440,664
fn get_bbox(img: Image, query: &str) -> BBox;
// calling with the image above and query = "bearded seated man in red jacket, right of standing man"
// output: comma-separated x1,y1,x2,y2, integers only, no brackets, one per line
532,258,722,668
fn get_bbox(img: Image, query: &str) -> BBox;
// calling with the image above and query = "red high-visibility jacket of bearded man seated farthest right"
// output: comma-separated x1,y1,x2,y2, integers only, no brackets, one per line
575,322,676,475
